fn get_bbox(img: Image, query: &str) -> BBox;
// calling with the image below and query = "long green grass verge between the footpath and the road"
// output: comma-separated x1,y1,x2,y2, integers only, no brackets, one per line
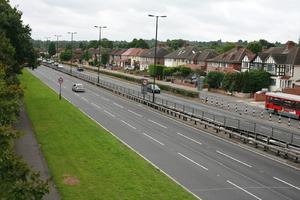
20,70,195,200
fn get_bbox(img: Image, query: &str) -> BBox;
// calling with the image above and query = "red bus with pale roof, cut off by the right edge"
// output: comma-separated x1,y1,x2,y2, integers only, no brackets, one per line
265,92,300,119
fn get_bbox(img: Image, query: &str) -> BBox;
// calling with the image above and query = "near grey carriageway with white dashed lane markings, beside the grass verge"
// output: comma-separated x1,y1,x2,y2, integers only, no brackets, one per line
32,67,300,200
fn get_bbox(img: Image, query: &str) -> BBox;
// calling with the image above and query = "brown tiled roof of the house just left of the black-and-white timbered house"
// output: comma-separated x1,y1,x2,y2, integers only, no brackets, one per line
208,47,255,63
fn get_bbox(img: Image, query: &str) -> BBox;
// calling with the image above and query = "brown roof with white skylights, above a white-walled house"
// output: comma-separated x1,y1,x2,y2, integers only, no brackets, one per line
165,46,200,60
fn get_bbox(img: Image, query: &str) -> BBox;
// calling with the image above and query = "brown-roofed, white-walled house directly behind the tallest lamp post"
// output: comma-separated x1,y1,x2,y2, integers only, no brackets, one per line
140,47,169,70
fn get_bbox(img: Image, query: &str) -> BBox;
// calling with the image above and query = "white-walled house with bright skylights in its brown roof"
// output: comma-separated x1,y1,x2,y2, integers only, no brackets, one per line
165,46,200,67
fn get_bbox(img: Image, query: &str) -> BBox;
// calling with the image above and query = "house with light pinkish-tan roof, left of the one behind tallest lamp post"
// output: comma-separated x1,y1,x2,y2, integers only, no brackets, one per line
121,48,146,69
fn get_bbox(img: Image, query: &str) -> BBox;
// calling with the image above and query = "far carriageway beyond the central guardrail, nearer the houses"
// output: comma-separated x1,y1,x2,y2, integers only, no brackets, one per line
59,65,300,146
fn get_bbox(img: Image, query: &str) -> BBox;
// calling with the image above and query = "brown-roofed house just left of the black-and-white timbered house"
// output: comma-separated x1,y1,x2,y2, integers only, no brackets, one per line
207,46,255,72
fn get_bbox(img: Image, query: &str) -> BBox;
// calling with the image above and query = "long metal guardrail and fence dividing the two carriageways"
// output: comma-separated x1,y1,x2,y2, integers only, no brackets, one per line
43,64,300,160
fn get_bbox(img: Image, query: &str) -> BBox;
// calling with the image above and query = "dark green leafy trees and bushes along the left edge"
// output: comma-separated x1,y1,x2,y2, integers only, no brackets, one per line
0,0,48,200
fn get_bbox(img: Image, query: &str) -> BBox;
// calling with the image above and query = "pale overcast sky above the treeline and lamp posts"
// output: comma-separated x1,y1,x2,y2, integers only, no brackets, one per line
10,0,300,43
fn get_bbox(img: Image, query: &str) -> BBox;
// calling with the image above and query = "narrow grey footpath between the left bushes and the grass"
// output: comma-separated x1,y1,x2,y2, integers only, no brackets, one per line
15,107,60,200
